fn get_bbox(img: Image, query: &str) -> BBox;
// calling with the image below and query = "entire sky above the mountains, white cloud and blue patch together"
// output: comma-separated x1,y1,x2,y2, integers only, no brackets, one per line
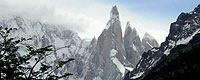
0,0,200,43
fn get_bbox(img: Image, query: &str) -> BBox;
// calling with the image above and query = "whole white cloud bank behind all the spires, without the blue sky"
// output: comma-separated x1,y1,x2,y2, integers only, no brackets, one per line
0,0,173,42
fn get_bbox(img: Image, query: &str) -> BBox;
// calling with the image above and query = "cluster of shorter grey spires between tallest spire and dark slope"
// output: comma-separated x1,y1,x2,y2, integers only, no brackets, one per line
124,22,159,67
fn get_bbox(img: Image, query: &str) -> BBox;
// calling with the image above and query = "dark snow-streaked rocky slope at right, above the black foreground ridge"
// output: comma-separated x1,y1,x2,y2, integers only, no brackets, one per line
125,5,200,80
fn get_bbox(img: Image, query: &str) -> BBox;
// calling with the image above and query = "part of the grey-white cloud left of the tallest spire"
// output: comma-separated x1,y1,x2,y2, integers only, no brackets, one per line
0,0,111,38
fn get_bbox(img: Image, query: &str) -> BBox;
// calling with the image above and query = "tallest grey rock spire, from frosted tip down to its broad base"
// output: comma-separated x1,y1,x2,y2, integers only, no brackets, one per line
85,6,131,80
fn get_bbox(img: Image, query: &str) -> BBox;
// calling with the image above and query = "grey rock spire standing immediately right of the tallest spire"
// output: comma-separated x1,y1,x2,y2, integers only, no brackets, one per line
124,22,144,66
